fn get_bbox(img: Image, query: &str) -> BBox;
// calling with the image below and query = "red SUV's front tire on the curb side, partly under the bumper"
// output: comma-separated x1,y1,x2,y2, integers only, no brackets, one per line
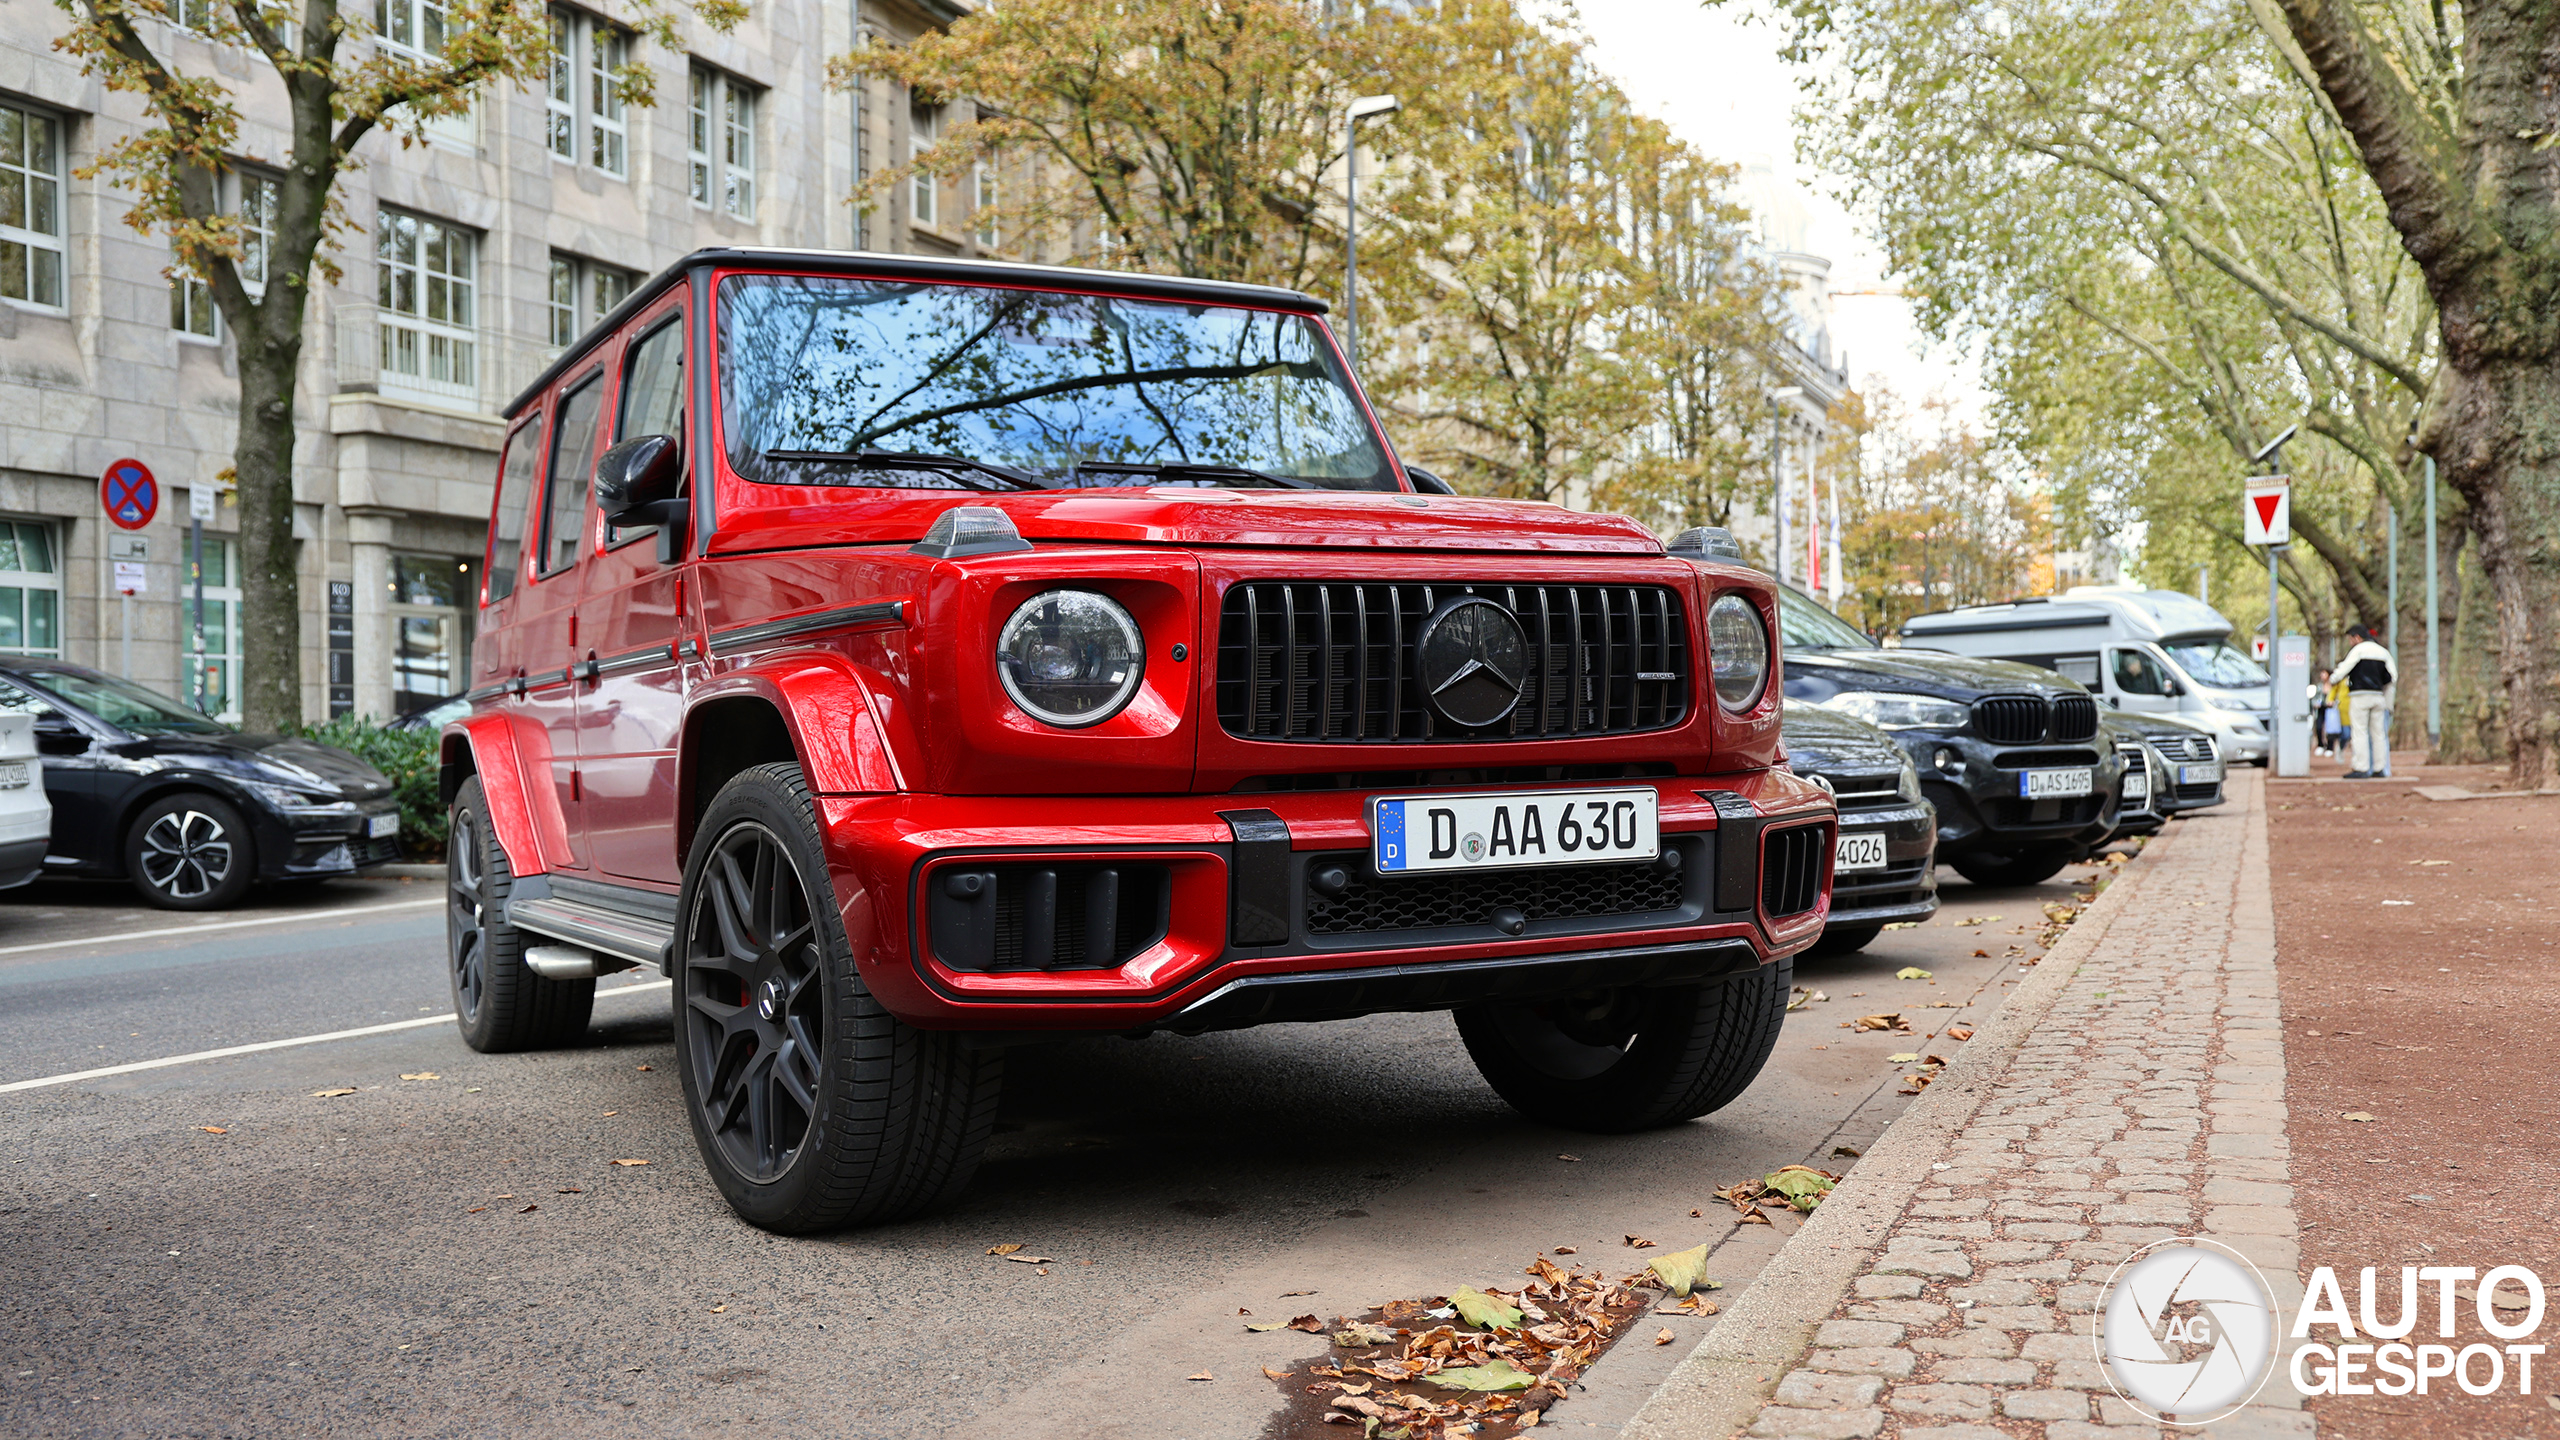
1457,958,1795,1135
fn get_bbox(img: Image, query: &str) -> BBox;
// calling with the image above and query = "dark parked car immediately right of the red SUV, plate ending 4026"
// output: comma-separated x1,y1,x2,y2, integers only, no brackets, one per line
1779,700,1938,956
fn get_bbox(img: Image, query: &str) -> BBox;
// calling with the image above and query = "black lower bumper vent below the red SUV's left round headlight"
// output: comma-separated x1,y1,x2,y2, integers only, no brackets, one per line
927,861,1172,974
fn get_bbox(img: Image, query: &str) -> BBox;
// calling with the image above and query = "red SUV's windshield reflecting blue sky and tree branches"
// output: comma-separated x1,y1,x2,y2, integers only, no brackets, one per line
719,274,1403,489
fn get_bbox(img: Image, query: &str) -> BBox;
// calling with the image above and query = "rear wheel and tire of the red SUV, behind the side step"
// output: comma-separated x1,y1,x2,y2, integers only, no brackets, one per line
445,776,596,1040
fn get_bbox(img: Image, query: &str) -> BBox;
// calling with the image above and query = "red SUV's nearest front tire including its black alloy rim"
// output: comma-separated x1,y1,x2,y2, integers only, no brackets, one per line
676,764,1004,1235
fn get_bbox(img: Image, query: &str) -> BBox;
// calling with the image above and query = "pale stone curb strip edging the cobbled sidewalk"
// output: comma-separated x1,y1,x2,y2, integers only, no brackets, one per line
1620,828,2179,1440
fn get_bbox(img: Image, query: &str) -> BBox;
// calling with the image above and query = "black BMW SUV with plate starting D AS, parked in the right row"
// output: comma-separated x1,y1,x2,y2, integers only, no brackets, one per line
1779,587,2125,884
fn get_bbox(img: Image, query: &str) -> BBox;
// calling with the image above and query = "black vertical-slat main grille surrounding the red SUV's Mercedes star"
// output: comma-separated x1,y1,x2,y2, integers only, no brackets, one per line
1219,579,1690,743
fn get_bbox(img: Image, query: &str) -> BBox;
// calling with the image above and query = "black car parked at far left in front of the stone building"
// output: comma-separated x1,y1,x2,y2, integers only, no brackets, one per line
0,659,399,910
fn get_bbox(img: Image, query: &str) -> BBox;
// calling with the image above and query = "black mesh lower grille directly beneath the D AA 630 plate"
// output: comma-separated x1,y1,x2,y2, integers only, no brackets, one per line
1306,851,1687,935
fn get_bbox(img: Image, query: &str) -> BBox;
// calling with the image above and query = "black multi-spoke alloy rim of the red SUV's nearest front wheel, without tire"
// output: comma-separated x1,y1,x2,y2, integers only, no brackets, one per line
684,822,827,1184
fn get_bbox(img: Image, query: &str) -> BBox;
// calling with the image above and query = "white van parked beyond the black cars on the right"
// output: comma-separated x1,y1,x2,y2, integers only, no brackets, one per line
1902,584,2268,766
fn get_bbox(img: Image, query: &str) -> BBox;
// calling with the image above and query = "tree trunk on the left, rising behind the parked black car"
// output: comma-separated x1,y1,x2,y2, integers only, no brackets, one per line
230,310,302,733
